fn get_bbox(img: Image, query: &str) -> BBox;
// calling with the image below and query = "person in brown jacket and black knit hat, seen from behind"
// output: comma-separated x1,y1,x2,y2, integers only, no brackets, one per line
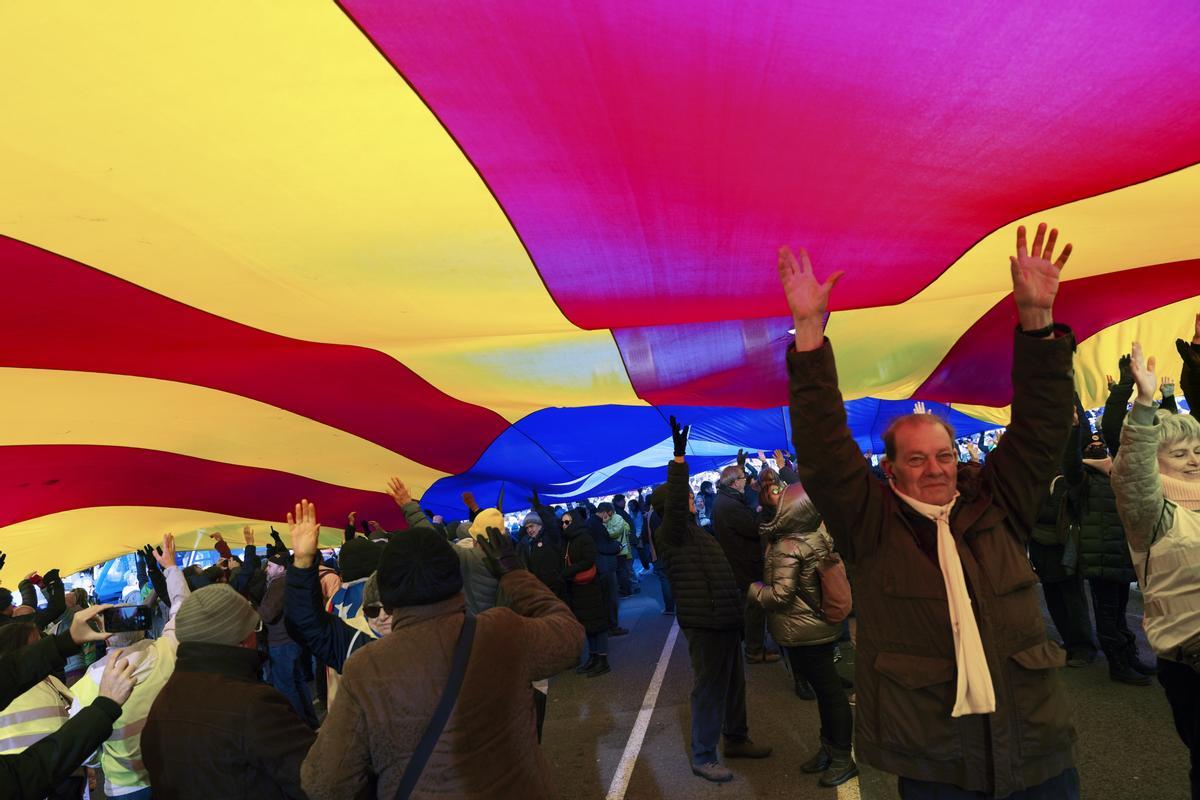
301,510,583,800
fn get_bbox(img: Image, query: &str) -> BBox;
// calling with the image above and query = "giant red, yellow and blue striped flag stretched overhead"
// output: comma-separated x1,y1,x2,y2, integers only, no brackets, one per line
0,0,1200,575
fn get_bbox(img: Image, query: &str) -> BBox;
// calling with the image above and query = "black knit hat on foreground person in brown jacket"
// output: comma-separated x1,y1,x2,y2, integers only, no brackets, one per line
379,527,462,608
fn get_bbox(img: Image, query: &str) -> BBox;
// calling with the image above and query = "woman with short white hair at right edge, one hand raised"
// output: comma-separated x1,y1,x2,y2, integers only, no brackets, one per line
1112,342,1200,798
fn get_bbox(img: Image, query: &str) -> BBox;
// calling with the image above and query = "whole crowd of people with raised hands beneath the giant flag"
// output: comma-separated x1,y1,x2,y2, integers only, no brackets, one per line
0,221,1200,800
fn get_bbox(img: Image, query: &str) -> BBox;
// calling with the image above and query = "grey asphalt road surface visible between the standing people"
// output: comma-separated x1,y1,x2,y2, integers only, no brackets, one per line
542,575,1189,800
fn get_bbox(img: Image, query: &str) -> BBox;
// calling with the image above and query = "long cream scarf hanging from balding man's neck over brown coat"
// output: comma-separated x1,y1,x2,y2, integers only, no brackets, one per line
892,485,996,717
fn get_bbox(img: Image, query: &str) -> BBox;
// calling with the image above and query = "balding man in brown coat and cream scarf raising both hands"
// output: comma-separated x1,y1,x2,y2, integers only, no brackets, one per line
779,225,1079,800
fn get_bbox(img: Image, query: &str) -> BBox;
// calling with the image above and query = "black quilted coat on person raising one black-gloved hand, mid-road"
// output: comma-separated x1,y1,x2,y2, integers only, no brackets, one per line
654,461,757,631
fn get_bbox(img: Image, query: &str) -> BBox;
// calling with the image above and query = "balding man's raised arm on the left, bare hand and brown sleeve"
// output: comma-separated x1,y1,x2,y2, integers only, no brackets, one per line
779,247,883,560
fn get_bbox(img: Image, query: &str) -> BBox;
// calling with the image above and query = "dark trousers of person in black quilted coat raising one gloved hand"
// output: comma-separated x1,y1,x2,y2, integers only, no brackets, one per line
683,627,749,766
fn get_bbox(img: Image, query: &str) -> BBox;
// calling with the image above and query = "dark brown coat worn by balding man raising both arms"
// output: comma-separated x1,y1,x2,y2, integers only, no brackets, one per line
787,333,1075,798
